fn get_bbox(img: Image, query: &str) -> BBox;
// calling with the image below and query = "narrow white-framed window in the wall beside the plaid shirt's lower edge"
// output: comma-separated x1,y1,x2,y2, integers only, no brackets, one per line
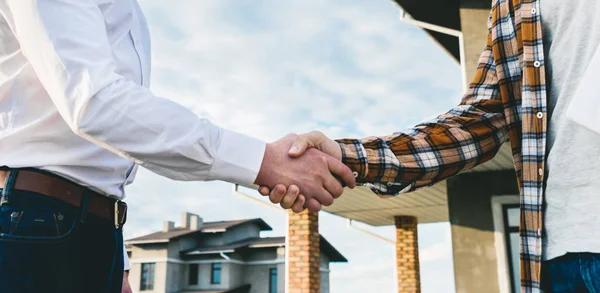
502,204,521,292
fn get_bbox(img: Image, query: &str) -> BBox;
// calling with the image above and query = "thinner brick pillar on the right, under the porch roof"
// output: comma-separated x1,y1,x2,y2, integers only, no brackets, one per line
394,216,421,293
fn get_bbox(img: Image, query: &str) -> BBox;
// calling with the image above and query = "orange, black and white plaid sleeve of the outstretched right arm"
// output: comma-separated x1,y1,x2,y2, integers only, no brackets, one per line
338,28,508,195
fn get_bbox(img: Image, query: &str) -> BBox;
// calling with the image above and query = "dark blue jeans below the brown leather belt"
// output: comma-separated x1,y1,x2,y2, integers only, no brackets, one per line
0,176,123,293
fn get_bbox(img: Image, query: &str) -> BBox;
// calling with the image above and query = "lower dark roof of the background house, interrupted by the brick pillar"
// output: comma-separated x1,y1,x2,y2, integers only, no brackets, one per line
181,235,348,262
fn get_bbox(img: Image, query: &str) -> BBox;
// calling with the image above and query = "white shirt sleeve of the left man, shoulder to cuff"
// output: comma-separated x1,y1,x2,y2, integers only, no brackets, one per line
3,0,265,186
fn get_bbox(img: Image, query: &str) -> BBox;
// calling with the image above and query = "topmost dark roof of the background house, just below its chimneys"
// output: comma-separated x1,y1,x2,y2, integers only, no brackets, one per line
127,218,273,244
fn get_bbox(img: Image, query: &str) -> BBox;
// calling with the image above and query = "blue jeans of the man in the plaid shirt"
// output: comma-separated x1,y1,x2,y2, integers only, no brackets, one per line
542,253,600,293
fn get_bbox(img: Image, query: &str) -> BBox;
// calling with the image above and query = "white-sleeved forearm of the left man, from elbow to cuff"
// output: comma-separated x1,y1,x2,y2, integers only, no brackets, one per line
73,81,265,186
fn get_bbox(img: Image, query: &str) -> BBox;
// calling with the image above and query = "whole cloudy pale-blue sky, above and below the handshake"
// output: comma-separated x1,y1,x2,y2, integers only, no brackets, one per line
126,0,461,293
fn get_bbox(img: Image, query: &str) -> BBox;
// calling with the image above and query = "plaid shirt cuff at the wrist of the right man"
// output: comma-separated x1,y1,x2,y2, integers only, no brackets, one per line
336,139,369,183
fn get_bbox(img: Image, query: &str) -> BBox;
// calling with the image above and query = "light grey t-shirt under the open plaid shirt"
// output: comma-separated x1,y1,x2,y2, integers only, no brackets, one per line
539,0,600,260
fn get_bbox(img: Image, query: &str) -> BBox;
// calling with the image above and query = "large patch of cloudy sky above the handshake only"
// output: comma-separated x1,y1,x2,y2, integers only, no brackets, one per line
139,0,460,139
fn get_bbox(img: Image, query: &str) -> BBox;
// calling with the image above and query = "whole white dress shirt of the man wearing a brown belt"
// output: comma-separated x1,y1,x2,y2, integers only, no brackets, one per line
0,0,265,270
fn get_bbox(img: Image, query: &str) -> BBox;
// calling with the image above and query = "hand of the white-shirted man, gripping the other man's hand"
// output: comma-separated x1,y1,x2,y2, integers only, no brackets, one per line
255,134,356,212
